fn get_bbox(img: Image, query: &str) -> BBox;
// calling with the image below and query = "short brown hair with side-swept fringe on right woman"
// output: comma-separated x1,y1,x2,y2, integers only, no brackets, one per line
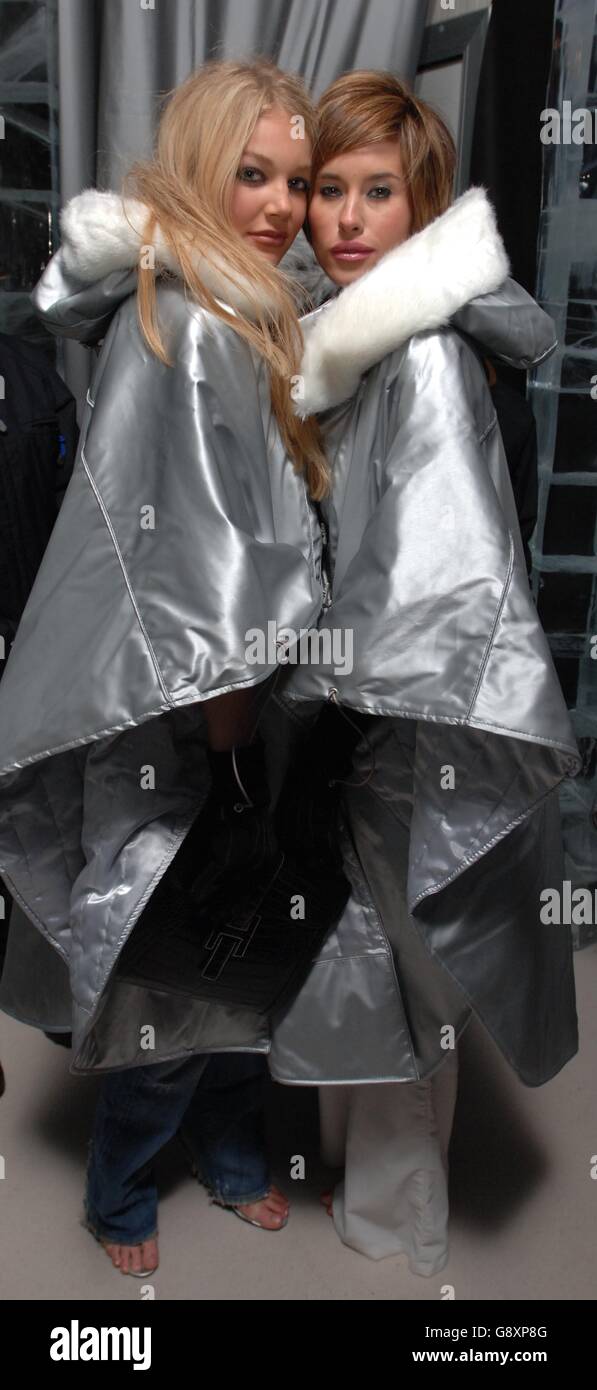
312,68,456,234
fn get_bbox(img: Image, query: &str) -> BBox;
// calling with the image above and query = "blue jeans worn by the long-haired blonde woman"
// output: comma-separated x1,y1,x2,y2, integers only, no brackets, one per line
85,1052,271,1245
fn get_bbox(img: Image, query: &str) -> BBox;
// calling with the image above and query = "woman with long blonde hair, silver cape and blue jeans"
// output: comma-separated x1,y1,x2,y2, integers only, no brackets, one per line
0,61,327,1275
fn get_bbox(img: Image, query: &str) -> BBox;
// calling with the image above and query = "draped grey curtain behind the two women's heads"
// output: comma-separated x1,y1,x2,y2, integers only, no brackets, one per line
58,0,427,399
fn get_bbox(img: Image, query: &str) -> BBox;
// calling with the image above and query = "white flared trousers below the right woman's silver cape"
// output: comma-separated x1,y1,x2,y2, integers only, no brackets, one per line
319,1048,458,1276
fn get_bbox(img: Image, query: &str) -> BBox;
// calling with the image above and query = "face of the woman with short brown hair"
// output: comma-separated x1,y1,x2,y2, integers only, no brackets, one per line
309,140,412,285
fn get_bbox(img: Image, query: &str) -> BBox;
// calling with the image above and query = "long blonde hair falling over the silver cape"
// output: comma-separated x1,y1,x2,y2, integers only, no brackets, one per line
122,58,330,499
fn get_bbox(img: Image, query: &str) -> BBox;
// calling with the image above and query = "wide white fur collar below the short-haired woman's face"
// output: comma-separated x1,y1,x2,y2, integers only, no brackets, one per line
294,188,509,418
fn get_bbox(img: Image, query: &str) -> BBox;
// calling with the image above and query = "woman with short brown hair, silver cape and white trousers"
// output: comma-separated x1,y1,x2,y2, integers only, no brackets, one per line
265,71,579,1276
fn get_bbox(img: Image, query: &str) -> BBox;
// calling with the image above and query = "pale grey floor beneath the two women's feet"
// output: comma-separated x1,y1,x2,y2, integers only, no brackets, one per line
0,945,597,1301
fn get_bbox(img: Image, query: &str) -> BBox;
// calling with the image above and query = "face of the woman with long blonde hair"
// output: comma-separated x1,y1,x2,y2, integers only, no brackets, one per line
231,107,312,265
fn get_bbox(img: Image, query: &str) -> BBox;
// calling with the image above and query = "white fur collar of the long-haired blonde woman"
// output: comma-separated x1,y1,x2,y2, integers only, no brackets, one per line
60,188,281,318
